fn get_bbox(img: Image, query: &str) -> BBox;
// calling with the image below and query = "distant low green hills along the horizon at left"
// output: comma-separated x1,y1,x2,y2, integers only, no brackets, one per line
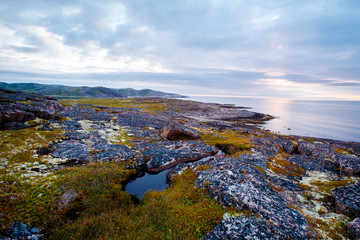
0,82,184,99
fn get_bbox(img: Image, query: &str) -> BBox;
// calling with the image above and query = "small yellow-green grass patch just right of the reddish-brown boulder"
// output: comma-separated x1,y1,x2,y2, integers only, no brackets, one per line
201,130,252,156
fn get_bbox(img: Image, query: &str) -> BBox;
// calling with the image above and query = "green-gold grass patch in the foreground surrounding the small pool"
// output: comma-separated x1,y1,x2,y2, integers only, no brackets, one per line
49,168,226,239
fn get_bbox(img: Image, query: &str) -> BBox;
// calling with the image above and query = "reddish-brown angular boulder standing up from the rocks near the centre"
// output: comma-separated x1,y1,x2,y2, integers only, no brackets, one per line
161,122,200,140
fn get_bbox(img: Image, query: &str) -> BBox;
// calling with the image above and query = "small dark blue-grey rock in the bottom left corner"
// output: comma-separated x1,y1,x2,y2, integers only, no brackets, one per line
7,222,43,240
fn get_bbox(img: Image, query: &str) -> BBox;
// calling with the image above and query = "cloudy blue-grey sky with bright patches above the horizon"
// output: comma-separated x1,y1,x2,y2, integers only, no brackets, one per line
0,0,360,100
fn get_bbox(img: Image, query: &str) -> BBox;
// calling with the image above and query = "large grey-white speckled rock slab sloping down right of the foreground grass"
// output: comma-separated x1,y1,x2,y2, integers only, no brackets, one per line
195,154,310,239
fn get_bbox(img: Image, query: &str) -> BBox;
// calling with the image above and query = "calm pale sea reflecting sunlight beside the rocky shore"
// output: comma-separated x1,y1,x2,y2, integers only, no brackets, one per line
187,97,360,142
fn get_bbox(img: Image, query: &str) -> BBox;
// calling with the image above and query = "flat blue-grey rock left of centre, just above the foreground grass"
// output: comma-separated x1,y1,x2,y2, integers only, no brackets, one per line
51,140,88,162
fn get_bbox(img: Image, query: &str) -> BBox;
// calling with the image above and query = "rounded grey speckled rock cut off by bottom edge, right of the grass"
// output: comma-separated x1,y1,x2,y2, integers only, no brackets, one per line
202,217,286,240
